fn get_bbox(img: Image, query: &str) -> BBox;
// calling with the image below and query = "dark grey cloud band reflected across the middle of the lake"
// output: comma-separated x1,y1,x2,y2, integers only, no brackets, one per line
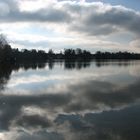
0,81,140,130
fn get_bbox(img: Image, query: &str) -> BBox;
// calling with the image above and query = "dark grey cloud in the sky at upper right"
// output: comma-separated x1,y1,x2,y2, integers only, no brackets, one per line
87,7,140,34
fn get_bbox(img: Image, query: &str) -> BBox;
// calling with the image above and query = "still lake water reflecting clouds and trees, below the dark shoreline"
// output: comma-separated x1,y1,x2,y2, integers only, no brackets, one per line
0,61,140,140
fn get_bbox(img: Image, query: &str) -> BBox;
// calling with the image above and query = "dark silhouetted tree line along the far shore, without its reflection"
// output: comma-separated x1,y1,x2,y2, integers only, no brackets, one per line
0,35,140,63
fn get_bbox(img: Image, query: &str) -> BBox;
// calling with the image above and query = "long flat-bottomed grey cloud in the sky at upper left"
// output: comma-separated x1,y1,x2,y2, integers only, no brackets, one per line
0,9,69,23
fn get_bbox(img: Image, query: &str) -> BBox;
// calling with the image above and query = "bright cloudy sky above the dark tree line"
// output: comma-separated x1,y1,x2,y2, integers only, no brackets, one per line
0,0,140,52
